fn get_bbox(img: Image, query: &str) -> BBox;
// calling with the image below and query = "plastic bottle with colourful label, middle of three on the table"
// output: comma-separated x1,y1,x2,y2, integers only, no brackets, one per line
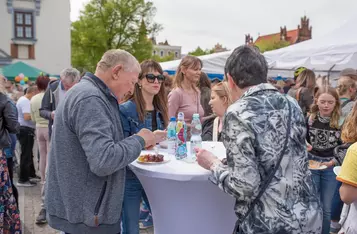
175,112,187,160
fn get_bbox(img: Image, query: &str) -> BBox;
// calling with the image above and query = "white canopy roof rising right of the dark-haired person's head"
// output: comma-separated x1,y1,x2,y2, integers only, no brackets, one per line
264,18,357,79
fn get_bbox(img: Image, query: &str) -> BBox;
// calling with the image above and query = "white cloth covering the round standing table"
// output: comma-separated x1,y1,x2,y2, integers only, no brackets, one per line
130,142,237,234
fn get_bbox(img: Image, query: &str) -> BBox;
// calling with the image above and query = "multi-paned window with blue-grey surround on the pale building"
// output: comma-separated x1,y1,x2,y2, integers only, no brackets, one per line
15,11,33,39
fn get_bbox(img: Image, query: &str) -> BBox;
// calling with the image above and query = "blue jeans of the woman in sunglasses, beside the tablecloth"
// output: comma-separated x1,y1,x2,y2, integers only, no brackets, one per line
122,169,150,234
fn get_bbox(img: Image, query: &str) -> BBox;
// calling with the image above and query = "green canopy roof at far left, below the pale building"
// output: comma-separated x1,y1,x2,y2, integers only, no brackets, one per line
2,61,46,80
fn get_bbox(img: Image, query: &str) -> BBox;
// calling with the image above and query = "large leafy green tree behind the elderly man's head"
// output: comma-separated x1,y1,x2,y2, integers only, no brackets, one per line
71,0,162,71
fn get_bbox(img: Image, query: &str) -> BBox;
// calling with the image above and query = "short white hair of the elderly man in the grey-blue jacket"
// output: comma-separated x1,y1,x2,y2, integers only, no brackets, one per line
97,49,141,72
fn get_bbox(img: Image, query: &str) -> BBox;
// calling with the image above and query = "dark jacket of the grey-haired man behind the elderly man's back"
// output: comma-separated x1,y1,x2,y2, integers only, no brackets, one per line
40,80,60,137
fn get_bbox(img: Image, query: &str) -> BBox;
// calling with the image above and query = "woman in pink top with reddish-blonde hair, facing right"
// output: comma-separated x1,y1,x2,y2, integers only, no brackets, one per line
169,55,204,126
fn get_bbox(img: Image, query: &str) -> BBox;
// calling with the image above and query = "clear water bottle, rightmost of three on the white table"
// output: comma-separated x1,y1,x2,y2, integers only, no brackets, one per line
186,114,202,162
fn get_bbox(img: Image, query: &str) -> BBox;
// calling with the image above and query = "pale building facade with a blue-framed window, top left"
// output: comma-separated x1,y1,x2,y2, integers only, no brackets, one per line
0,0,71,75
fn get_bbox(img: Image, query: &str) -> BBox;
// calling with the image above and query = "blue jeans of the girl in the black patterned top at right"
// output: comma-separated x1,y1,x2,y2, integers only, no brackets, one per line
311,164,337,234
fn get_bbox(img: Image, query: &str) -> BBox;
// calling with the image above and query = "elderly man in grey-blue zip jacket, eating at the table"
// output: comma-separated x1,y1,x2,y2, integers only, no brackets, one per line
45,50,163,234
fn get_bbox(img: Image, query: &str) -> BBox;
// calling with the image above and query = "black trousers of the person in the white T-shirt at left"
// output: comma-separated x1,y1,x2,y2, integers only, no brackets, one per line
17,126,36,182
